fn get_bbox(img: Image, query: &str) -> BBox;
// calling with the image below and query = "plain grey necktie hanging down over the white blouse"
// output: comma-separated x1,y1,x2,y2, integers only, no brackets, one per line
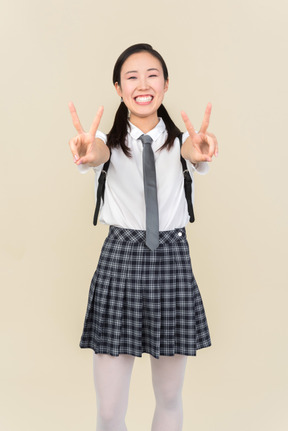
139,135,159,250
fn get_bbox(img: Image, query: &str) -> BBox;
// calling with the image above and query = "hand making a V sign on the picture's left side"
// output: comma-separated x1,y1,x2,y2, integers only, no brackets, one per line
69,102,108,166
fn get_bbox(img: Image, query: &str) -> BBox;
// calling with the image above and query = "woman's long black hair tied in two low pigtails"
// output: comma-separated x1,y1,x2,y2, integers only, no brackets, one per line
107,43,180,157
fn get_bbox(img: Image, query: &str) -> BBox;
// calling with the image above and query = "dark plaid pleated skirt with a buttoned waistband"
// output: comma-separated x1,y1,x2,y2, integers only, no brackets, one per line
80,226,211,358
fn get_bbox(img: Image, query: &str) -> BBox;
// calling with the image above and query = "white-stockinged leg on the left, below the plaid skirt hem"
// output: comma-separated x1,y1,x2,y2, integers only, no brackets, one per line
93,353,134,431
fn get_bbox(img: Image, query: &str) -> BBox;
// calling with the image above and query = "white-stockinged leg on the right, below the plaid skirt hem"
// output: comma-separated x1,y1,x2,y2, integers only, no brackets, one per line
151,355,187,431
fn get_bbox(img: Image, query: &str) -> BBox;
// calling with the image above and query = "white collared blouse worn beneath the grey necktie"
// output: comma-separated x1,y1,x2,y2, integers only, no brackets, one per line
79,118,209,231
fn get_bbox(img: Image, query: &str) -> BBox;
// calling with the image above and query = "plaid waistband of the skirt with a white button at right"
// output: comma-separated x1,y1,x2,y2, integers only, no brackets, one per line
109,226,186,245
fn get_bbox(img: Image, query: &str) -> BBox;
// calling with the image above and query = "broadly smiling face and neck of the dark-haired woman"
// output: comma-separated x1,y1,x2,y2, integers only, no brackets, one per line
115,51,168,131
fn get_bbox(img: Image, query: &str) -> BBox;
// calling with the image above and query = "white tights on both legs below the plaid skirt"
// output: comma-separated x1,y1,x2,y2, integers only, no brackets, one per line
93,354,187,431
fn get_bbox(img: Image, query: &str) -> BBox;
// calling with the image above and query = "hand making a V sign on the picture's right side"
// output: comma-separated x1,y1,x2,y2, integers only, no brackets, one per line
181,103,218,164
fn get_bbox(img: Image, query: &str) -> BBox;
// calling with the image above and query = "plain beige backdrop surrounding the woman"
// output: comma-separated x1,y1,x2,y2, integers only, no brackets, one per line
0,0,288,431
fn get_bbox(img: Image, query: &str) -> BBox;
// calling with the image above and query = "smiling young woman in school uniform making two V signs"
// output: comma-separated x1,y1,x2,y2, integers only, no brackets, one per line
69,44,218,431
